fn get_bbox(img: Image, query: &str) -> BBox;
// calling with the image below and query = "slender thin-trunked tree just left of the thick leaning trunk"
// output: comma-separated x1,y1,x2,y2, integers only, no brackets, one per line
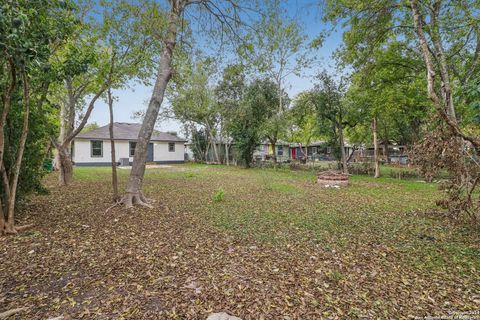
98,0,161,202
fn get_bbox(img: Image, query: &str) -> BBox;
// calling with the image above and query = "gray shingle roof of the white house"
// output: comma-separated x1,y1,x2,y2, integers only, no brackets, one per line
75,122,186,142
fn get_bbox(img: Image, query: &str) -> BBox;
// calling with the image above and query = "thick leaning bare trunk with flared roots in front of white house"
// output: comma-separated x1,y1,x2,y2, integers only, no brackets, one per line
122,1,185,208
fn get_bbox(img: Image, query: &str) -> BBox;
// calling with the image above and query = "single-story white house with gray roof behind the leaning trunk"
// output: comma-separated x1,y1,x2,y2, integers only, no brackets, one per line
72,122,186,166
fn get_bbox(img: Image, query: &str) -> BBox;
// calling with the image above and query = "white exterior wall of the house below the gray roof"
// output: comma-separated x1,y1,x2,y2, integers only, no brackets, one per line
73,139,185,163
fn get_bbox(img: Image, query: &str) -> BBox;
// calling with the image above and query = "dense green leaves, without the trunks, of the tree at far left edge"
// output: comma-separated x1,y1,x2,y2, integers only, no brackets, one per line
0,0,77,205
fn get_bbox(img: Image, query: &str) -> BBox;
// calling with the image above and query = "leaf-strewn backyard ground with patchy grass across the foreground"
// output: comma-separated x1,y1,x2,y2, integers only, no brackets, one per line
0,165,480,320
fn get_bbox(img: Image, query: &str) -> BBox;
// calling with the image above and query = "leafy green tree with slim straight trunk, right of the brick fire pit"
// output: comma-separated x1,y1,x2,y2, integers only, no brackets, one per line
347,41,428,177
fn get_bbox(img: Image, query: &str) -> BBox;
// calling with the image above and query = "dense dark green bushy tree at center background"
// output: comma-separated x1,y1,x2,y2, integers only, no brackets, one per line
231,80,278,168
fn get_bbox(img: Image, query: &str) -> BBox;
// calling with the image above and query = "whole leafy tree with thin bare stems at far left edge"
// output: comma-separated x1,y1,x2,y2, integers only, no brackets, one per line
0,0,74,234
